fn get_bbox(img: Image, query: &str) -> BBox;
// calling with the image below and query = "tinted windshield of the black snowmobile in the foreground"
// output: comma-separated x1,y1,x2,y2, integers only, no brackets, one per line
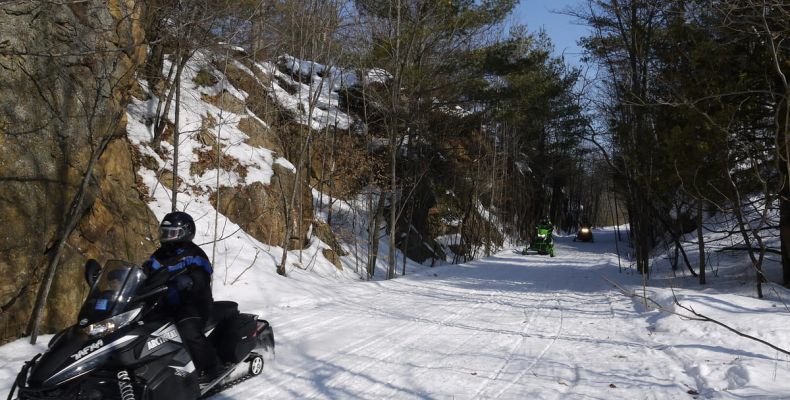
79,260,145,325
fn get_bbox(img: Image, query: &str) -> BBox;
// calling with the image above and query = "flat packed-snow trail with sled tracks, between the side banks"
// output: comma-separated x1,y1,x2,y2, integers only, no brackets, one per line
214,232,697,399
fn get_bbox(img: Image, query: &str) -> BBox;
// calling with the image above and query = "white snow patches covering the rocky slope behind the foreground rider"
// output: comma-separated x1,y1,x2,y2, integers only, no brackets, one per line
127,48,420,284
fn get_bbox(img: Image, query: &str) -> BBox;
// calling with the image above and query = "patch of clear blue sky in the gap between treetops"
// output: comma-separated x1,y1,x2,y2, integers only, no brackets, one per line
511,0,587,66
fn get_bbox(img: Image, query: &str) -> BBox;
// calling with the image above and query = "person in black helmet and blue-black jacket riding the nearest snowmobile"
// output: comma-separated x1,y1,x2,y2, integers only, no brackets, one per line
143,212,222,383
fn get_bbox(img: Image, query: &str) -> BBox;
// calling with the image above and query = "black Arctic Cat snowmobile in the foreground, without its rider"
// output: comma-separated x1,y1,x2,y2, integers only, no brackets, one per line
8,260,274,400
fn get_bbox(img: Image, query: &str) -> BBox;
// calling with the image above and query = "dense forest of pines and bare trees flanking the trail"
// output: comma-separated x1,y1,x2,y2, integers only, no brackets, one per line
173,0,790,295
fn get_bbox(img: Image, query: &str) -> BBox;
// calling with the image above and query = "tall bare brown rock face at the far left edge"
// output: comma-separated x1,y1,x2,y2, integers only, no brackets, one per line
0,0,156,341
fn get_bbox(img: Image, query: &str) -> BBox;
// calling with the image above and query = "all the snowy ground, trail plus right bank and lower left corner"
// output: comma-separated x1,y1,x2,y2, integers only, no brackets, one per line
0,227,790,400
